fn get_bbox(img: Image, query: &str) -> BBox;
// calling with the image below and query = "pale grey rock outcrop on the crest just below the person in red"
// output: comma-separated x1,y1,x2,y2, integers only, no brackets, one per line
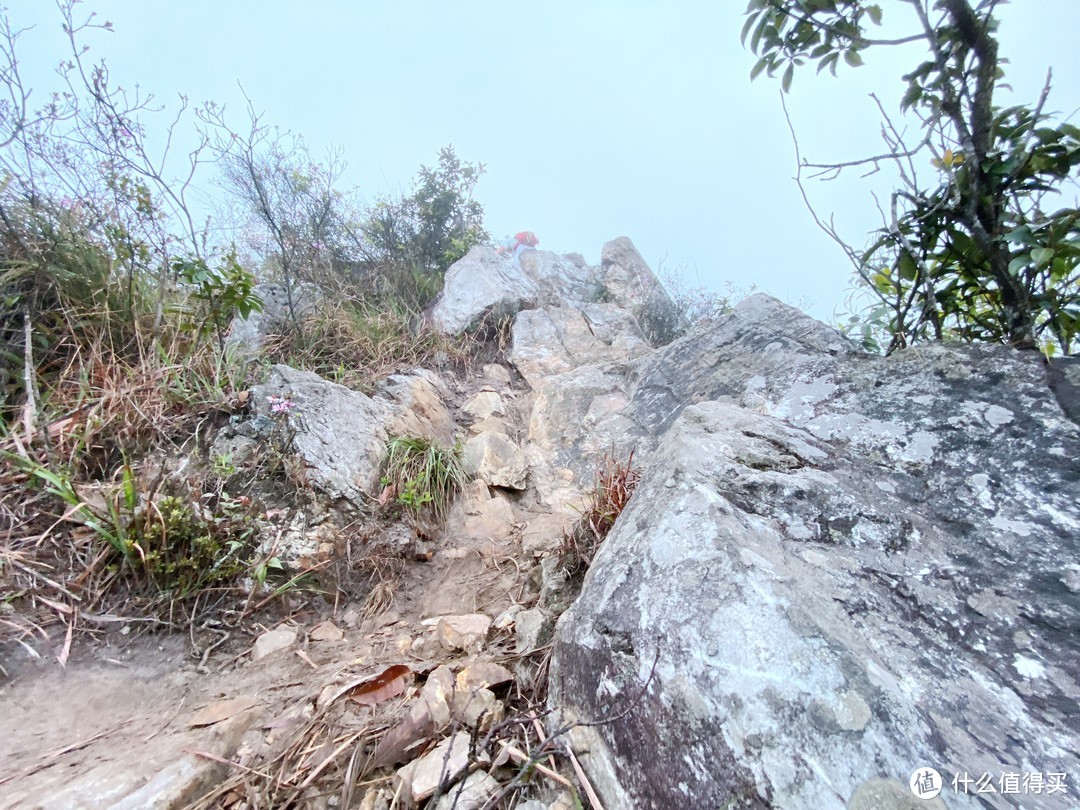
432,245,599,335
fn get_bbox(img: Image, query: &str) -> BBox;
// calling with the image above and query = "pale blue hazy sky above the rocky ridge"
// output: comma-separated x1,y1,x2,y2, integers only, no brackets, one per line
8,0,1080,320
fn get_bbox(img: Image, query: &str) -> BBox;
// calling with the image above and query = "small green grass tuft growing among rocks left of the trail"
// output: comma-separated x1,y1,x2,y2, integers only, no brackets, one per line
379,436,467,523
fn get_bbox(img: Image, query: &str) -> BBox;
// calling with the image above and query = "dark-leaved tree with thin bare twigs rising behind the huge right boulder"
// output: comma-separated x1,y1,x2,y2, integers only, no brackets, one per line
743,0,1080,353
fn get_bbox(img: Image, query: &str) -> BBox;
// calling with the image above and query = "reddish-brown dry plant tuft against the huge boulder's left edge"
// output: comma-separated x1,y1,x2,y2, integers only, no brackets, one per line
559,450,642,579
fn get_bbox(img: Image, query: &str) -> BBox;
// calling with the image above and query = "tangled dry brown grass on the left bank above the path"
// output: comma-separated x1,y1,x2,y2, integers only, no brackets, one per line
0,309,282,649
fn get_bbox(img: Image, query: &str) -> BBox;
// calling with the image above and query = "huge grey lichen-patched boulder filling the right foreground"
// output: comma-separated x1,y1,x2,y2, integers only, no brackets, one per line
551,297,1080,808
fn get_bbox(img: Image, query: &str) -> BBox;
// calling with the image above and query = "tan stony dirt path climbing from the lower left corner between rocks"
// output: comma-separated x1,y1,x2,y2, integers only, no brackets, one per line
0,365,564,808
